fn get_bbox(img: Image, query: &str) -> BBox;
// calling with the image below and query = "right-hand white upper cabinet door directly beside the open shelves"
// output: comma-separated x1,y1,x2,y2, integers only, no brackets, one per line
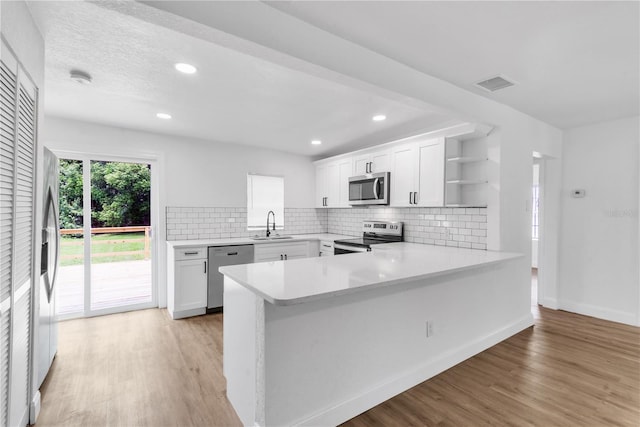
417,138,445,206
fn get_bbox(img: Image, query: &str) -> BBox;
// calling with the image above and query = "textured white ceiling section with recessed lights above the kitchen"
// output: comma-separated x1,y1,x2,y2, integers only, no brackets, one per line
28,1,451,156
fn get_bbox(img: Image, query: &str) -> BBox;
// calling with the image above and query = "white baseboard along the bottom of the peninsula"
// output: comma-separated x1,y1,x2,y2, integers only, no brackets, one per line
297,314,534,426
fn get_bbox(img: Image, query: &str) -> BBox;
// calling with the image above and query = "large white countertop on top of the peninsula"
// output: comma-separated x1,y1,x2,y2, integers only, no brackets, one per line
219,243,522,305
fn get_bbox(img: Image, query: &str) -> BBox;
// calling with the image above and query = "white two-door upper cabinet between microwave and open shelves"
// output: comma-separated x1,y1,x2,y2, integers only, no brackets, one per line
391,138,445,207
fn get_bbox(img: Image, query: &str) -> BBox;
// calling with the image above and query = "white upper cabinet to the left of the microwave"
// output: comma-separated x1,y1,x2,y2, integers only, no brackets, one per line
315,157,353,208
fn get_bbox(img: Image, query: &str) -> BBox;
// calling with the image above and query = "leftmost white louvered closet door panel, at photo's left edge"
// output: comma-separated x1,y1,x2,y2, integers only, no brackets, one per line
0,58,16,426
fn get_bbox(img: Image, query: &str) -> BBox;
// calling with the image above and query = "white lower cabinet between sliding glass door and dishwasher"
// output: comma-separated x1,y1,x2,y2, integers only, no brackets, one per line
167,246,208,319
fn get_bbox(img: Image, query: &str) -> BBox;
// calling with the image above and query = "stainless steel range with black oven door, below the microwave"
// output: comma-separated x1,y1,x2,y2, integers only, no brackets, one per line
333,221,403,255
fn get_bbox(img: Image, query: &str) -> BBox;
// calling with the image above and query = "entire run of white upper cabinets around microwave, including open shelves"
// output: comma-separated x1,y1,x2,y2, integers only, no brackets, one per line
316,123,492,208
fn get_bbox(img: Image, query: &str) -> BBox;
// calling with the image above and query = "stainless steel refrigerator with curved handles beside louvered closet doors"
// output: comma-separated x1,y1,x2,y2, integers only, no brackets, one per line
38,148,60,387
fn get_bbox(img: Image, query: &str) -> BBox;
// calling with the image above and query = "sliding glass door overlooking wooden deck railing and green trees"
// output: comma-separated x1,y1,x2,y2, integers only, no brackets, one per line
56,156,158,319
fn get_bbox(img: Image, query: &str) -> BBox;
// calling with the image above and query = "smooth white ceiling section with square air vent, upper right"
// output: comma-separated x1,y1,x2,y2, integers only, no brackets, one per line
267,1,640,128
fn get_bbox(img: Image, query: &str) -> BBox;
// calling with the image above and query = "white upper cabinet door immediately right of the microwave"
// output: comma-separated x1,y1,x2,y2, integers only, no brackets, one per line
390,144,418,206
